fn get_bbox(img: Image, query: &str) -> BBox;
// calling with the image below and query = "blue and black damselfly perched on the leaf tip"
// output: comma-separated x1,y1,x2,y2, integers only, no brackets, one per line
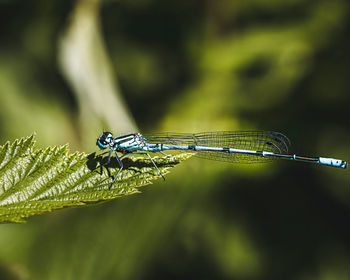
96,131,347,188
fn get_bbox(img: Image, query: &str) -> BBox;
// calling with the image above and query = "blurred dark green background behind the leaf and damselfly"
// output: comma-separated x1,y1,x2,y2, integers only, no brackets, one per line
0,0,350,280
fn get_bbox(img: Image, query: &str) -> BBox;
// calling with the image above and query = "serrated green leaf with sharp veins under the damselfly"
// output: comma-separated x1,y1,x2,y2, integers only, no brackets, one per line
0,135,191,223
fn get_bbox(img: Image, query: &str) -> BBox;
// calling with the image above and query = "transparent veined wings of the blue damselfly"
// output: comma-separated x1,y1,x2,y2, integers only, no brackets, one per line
143,131,290,163
